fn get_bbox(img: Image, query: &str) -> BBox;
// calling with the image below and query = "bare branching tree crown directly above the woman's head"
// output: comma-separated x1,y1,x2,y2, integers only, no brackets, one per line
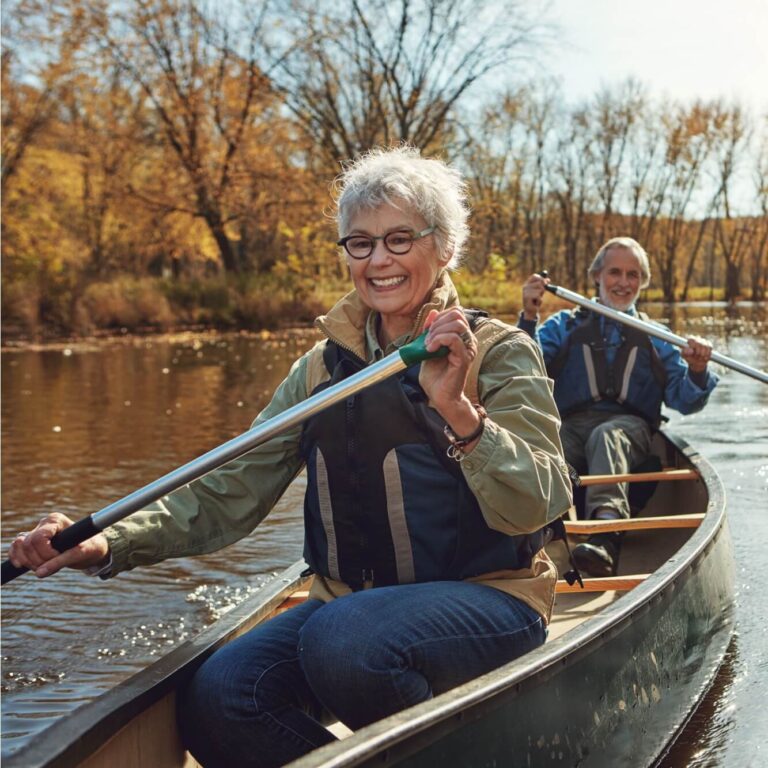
273,0,545,170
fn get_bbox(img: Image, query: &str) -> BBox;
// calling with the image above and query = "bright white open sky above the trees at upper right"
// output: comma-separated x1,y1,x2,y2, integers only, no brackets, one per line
547,0,768,116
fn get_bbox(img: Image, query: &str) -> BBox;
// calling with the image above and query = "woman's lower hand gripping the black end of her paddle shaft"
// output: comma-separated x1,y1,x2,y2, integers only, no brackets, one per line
8,512,109,578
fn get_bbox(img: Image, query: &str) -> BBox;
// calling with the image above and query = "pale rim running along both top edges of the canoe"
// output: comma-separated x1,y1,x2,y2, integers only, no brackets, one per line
4,435,727,768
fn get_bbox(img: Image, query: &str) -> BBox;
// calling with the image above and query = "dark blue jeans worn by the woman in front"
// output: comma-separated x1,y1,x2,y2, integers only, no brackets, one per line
178,581,546,768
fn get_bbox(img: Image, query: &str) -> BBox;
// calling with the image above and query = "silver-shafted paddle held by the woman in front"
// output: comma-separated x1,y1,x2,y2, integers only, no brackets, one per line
1,331,448,584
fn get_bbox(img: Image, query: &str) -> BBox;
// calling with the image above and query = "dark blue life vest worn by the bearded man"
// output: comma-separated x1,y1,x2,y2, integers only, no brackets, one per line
547,308,667,428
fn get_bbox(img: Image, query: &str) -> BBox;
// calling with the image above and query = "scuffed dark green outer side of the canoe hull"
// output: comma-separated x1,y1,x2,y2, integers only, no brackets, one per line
320,510,733,768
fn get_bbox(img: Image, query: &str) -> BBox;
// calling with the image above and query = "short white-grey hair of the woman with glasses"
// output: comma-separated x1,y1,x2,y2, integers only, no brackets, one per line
334,145,469,269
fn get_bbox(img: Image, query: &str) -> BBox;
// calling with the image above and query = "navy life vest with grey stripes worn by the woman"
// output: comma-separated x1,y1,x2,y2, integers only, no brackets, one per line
301,340,545,589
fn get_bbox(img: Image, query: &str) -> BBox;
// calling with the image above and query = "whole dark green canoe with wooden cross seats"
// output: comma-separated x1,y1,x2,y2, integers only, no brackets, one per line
4,433,734,768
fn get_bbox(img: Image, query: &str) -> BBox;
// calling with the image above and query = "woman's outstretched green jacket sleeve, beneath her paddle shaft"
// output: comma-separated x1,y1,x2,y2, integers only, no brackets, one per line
105,355,307,576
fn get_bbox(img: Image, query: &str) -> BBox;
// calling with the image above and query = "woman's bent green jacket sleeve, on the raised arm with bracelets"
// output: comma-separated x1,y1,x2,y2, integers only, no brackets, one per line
452,333,572,534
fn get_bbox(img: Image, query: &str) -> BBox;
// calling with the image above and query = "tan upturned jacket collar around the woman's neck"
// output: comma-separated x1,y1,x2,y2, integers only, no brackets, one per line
315,270,459,360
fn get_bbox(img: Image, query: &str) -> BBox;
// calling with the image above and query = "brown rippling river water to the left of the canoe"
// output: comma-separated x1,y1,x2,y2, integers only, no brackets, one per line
2,332,316,751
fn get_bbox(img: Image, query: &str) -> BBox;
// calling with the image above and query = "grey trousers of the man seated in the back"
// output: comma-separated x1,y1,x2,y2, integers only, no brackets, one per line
560,410,651,519
